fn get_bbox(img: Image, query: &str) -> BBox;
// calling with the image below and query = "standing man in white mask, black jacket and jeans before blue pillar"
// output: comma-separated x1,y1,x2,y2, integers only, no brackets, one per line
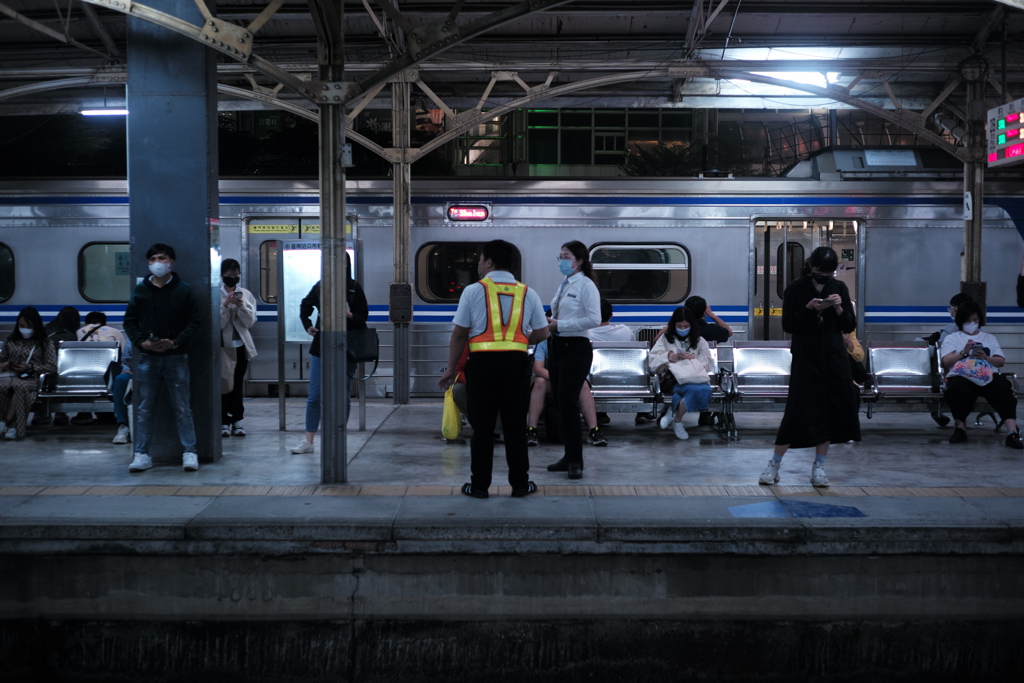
124,244,203,472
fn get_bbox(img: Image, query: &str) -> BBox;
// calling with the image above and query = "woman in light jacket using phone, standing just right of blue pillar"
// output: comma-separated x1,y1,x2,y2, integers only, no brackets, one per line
220,258,256,436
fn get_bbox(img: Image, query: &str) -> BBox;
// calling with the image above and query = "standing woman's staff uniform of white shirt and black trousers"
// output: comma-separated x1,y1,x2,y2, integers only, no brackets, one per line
548,270,601,469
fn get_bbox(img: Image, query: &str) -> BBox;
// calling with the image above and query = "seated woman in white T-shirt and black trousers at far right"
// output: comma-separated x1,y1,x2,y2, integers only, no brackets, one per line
939,301,1024,449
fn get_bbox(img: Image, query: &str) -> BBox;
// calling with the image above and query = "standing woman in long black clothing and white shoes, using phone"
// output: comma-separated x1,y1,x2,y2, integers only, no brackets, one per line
760,247,860,487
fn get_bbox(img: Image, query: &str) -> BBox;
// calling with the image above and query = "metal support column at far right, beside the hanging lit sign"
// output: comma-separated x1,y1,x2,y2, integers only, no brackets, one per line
961,81,986,309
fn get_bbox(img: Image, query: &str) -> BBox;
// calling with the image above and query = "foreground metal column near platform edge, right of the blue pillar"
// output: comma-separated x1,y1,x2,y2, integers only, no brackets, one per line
310,2,351,483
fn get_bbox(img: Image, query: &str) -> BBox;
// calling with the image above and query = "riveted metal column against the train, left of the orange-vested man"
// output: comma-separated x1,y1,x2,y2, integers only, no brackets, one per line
388,75,412,404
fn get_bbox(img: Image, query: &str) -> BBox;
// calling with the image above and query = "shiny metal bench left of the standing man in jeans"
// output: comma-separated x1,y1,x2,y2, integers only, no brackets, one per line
36,341,121,414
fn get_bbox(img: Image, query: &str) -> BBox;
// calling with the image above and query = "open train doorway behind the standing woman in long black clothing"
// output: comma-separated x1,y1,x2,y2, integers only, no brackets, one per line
749,218,859,340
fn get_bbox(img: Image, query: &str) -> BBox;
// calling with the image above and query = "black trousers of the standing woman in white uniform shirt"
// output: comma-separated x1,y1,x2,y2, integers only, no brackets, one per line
548,337,594,464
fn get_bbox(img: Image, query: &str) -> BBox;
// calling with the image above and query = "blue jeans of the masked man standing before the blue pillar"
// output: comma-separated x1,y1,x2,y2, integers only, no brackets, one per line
132,353,196,454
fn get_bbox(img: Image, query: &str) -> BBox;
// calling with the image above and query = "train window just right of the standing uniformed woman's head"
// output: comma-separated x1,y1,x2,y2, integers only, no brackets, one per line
590,245,690,303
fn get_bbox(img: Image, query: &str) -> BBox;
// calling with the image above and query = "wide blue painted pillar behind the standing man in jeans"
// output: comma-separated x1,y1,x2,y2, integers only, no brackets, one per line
127,0,221,463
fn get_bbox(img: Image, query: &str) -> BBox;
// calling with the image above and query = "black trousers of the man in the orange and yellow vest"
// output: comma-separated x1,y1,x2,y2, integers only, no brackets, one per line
466,351,530,490
